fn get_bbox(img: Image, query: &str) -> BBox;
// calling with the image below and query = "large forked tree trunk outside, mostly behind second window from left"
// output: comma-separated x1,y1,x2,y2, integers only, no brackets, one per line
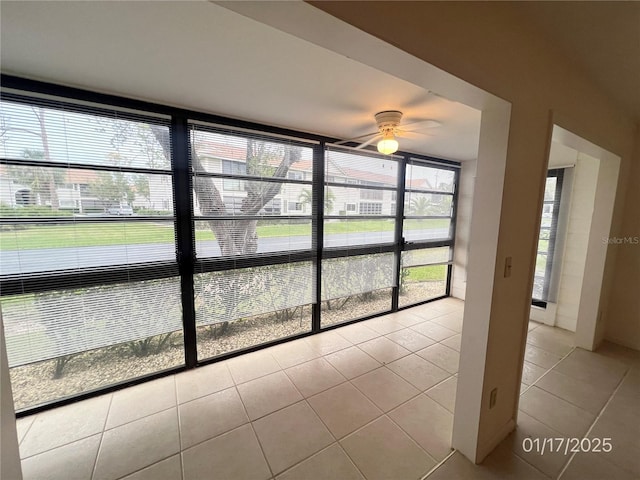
151,126,302,256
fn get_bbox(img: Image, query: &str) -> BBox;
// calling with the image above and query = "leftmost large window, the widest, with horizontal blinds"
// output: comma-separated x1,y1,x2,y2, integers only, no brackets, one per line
0,95,184,409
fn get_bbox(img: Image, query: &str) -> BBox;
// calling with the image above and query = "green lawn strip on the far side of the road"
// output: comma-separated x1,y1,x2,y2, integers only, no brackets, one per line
0,219,447,251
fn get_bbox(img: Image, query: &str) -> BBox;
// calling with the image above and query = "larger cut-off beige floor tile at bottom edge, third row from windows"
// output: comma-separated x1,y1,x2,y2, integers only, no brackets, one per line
182,425,272,480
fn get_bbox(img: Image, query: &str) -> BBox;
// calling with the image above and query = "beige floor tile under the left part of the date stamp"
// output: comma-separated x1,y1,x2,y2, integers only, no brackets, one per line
503,411,569,478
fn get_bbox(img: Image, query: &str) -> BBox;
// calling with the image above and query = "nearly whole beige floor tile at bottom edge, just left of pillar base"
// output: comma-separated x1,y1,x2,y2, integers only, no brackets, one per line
340,416,436,480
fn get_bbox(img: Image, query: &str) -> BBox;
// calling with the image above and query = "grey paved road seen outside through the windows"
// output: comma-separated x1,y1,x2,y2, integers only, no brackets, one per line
0,228,448,275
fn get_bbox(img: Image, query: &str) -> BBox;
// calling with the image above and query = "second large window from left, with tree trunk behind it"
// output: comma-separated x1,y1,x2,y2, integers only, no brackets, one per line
191,122,315,358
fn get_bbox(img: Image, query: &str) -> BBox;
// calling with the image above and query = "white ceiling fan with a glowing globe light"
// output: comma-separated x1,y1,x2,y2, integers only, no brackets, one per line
336,110,442,155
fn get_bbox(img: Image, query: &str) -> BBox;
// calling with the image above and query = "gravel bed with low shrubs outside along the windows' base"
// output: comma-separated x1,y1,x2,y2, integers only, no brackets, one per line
11,281,444,410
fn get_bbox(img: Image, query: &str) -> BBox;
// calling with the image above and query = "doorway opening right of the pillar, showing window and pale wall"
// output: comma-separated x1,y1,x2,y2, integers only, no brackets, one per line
531,125,620,350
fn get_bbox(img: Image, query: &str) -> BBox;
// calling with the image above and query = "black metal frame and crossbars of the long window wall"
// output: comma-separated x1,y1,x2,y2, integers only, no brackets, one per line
0,74,460,417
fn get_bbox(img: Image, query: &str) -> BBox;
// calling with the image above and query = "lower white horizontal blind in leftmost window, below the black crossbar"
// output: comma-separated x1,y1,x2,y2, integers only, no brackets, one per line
2,278,182,367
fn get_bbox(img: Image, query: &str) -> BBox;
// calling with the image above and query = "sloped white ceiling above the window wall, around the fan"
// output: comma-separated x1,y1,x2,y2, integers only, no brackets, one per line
0,1,480,160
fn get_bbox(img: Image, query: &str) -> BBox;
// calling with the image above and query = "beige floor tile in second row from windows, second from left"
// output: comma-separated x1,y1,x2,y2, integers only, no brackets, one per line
93,407,180,480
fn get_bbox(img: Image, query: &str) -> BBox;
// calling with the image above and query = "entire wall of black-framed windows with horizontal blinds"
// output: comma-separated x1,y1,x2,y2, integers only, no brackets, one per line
0,76,457,414
